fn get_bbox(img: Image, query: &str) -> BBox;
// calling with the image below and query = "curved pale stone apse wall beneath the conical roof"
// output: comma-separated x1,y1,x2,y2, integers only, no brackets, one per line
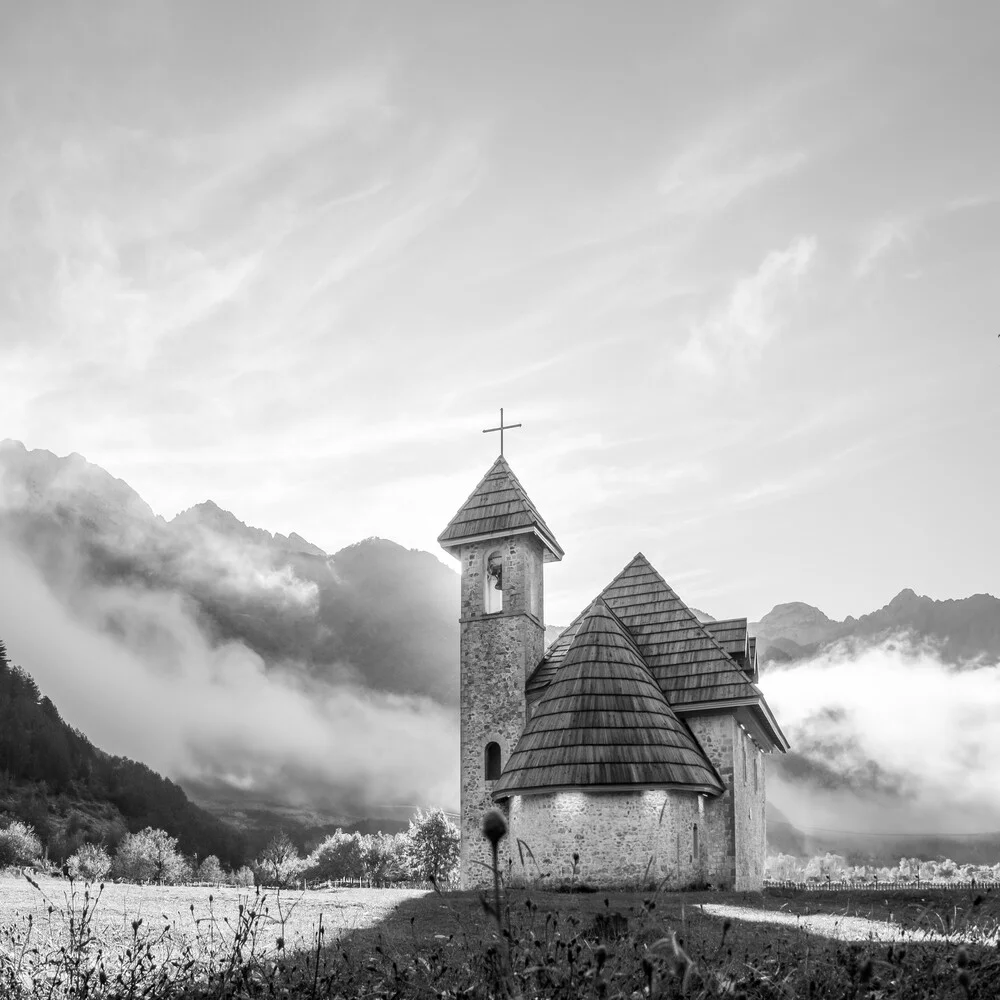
510,790,705,888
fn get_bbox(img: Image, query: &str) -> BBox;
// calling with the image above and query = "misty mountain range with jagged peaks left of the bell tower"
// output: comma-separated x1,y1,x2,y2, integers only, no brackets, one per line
0,441,458,704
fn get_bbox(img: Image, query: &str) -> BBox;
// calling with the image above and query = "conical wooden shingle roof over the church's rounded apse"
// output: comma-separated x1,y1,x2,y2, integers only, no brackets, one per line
493,599,724,799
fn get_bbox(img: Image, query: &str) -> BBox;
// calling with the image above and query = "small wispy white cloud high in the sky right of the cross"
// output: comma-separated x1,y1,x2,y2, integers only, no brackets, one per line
680,236,816,374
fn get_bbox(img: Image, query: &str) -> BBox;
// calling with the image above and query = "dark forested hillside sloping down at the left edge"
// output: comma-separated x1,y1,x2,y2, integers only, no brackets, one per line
0,642,248,866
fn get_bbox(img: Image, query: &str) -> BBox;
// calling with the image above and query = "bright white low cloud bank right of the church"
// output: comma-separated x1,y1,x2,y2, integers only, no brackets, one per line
761,640,1000,833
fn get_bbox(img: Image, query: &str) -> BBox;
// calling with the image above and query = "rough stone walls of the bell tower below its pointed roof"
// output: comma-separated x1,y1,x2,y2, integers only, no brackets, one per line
460,534,545,887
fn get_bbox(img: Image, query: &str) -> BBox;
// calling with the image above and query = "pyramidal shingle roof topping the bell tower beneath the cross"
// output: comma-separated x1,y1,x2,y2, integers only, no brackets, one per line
438,455,563,562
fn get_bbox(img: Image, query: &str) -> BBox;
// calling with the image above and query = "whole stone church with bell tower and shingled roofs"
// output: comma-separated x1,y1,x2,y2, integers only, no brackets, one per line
438,450,788,890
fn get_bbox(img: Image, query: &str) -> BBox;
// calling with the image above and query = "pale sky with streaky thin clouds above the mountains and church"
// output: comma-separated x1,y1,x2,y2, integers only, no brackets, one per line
0,0,1000,624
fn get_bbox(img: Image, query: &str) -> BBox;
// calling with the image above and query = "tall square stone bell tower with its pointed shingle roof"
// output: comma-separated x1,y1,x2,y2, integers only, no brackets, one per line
438,454,563,888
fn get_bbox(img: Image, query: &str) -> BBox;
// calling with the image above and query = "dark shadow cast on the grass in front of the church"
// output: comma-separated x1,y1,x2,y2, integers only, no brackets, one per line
260,890,1000,1000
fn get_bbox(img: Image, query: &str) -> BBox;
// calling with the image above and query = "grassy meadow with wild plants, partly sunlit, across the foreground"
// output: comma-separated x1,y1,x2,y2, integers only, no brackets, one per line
0,876,1000,1000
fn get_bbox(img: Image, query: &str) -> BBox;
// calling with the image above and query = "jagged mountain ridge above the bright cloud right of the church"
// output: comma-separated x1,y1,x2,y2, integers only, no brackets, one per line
749,589,1000,666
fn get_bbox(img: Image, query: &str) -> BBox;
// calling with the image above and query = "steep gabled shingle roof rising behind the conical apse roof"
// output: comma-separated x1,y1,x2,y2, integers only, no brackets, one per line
525,552,763,711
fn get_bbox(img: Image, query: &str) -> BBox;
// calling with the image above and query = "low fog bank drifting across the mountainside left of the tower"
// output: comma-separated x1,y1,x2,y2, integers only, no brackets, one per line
0,543,458,816
